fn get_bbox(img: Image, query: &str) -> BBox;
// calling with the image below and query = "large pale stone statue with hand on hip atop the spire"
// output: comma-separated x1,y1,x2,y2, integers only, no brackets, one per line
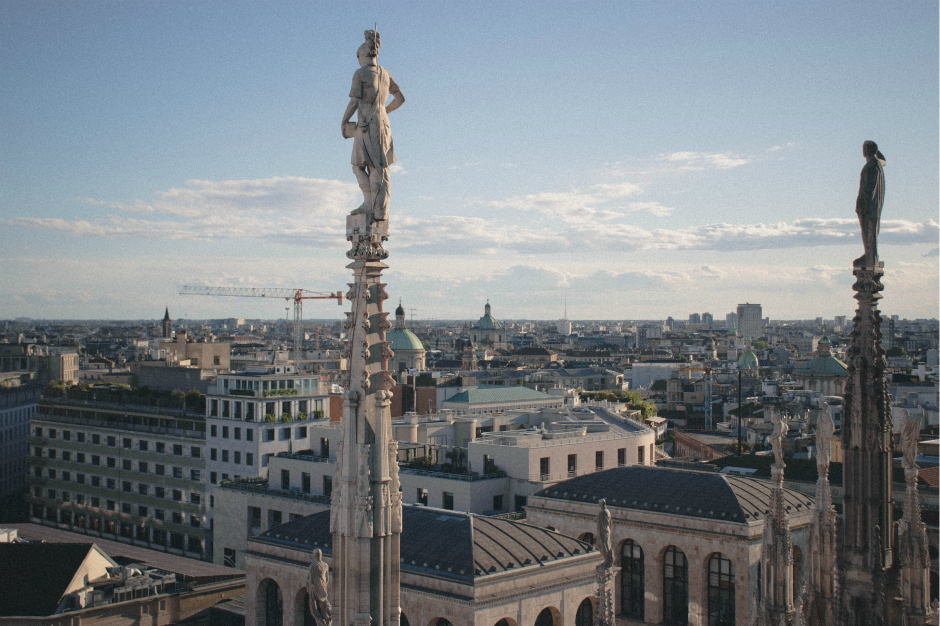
342,30,405,224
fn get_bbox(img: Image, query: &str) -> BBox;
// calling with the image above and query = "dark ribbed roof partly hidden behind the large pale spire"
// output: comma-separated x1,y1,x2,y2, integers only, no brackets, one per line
251,505,593,583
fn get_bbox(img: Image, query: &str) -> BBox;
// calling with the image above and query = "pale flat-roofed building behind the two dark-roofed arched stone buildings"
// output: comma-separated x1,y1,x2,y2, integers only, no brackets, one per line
214,407,656,568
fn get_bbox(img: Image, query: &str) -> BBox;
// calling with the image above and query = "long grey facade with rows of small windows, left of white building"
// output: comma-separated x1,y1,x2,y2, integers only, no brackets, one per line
26,400,211,559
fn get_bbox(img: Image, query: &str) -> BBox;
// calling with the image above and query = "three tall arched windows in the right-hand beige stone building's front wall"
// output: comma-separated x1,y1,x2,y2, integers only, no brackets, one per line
619,539,735,626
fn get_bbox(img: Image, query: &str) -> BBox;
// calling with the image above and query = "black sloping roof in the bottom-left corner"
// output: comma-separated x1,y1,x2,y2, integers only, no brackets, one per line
0,543,92,617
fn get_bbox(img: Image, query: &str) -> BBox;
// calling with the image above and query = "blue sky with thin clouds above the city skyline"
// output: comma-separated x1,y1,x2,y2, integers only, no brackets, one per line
0,0,940,319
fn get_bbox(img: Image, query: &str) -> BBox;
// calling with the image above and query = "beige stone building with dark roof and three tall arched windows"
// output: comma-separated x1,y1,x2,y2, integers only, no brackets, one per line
526,467,813,626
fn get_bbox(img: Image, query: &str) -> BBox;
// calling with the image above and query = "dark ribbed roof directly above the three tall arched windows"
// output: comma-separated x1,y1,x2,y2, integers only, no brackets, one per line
535,465,813,524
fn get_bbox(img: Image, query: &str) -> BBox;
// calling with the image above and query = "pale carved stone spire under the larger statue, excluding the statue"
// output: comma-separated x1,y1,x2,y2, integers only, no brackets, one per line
330,214,401,626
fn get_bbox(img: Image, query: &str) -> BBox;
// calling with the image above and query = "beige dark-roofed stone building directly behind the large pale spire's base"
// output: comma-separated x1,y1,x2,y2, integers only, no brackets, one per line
245,506,602,626
